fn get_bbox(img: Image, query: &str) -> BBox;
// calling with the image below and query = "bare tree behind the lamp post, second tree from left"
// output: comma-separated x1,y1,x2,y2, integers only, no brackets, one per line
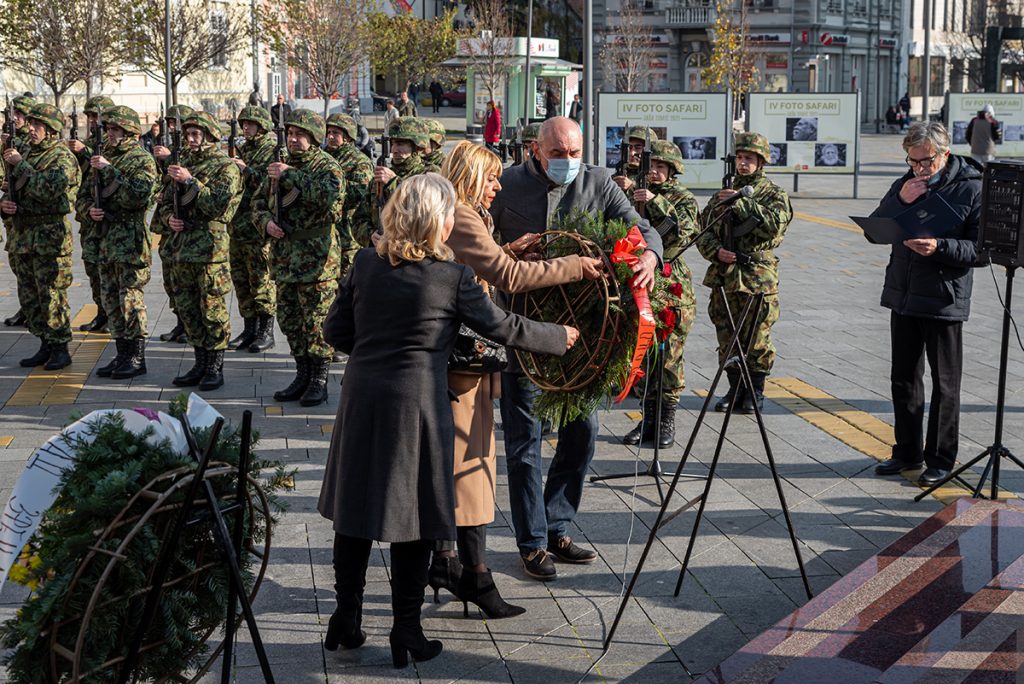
128,0,252,102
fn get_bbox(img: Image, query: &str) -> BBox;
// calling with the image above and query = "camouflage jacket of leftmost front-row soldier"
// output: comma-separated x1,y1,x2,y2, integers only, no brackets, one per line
1,136,82,255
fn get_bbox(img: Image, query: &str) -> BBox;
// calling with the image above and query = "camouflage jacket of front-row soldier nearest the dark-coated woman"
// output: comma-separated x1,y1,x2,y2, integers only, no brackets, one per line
253,147,345,285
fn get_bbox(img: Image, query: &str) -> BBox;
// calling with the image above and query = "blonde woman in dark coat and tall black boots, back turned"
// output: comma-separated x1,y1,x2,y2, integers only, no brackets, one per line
319,173,578,668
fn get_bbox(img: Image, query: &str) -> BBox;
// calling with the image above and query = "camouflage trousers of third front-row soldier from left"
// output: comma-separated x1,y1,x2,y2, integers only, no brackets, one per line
170,262,231,351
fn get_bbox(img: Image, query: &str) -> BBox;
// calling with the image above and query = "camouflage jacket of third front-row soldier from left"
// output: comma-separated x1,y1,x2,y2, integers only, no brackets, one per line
157,143,242,263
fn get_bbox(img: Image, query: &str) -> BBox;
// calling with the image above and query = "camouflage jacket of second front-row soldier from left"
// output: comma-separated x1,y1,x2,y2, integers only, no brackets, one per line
76,137,157,267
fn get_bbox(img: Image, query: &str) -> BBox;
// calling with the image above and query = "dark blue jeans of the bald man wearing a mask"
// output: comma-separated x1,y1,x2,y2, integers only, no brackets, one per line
501,373,598,553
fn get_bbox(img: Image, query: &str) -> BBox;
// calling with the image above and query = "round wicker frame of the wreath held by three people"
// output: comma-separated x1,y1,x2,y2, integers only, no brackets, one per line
512,230,624,392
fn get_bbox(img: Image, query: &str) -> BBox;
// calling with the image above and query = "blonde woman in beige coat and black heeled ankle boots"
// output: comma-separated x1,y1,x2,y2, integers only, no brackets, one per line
429,140,602,618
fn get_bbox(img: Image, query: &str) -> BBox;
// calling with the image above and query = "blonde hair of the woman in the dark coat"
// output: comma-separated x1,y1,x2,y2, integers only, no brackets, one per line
377,173,455,266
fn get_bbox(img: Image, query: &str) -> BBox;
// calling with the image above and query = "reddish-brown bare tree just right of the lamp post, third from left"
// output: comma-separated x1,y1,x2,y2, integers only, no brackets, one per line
262,0,378,119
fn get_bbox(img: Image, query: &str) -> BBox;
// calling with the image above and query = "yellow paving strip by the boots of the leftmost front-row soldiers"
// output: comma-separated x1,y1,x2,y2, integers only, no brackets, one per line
6,304,111,407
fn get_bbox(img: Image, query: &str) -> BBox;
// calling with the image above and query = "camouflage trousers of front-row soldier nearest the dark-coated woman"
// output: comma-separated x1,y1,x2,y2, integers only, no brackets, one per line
278,281,338,358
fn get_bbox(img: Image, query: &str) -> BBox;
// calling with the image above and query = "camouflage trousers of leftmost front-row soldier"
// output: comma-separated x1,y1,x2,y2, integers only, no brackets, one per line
9,254,72,344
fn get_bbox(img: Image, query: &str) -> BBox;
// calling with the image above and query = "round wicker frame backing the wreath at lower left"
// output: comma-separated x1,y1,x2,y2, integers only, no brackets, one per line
42,463,271,684
